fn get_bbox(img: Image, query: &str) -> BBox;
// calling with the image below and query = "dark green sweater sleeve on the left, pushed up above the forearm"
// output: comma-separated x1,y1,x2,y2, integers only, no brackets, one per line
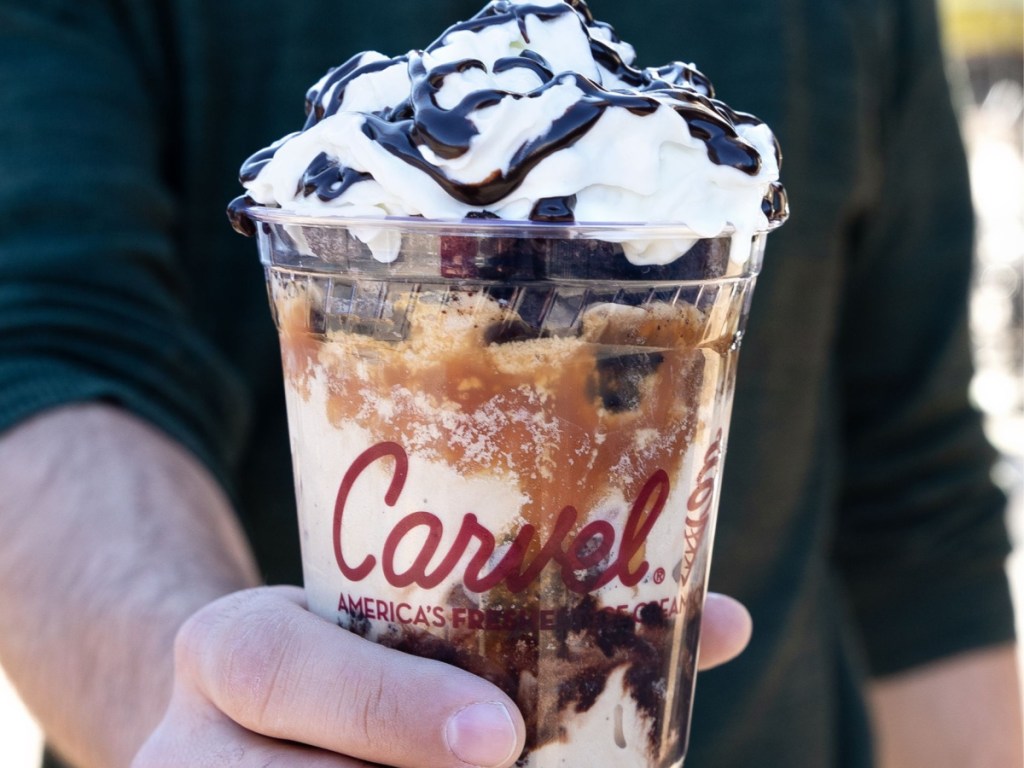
0,0,244,493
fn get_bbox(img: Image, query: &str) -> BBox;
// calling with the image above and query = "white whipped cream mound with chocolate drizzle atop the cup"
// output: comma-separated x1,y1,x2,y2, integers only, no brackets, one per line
233,0,786,263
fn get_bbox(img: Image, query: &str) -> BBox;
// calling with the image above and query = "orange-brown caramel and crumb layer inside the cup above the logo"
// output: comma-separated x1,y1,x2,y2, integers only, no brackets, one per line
278,294,708,532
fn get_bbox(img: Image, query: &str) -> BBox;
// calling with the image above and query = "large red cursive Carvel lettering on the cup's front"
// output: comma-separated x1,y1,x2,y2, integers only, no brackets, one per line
333,442,718,594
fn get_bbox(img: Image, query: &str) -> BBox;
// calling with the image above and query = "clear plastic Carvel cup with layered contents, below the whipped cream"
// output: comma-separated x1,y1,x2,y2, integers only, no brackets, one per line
251,209,766,768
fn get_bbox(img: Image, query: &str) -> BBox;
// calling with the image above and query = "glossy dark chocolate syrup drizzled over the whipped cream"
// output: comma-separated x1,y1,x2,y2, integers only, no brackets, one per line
228,0,781,233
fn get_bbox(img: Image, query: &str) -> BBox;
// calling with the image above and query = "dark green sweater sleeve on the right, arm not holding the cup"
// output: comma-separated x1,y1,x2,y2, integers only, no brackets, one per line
837,0,1014,675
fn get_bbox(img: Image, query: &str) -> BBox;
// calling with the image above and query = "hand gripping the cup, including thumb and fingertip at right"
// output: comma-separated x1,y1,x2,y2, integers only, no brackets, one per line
132,587,750,768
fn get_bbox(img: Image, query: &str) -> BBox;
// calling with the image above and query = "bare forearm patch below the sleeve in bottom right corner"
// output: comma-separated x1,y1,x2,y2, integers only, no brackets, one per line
870,646,1024,768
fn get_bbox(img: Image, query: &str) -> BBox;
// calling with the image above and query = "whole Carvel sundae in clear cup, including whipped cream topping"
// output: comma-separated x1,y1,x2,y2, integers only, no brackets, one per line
230,0,786,768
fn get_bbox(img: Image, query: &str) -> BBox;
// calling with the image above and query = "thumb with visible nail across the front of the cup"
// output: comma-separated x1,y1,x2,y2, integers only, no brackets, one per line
179,588,525,768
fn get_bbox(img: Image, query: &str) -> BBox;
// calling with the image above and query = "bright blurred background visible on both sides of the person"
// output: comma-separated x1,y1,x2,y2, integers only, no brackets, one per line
0,0,1024,768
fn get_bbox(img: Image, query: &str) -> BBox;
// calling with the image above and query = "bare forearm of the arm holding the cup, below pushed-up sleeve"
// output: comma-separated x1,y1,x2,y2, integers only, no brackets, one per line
0,406,258,768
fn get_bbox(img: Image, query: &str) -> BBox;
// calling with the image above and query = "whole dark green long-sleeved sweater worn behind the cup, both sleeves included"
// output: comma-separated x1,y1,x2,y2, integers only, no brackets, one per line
0,0,1013,768
